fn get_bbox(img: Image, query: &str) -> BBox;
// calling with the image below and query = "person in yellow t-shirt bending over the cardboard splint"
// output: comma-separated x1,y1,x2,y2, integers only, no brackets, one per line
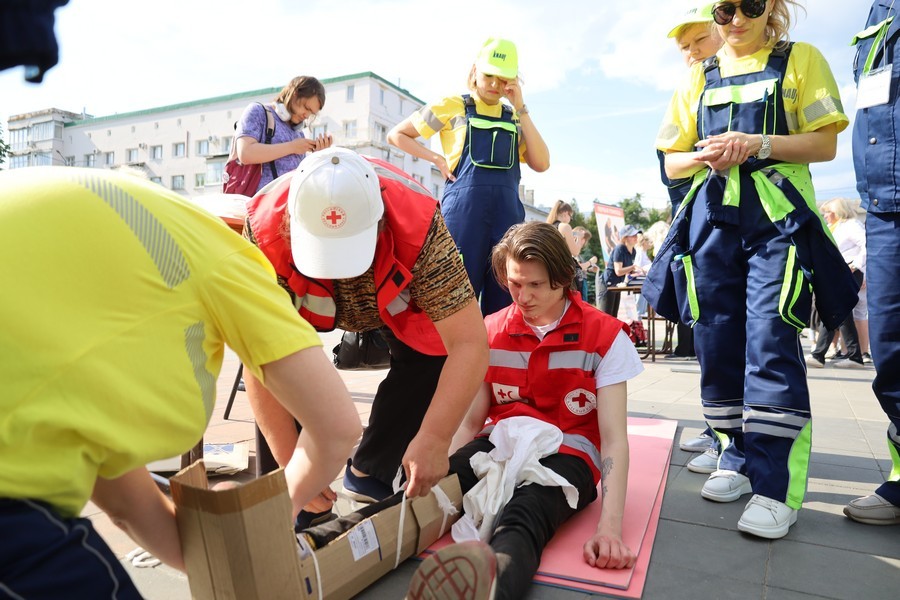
0,167,361,598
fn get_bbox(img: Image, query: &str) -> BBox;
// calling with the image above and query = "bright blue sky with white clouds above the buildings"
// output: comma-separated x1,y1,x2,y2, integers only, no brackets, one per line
0,0,870,209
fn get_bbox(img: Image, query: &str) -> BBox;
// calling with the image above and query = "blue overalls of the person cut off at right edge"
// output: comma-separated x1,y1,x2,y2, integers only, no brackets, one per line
853,0,900,506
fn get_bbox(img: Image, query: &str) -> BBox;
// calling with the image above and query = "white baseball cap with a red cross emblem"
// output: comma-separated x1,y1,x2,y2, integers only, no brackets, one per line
287,147,384,279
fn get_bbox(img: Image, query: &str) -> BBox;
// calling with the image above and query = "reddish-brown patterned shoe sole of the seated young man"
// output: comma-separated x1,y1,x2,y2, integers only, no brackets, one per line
406,542,497,600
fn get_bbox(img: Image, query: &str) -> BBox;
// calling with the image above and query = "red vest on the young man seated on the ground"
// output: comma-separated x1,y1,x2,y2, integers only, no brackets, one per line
485,291,627,483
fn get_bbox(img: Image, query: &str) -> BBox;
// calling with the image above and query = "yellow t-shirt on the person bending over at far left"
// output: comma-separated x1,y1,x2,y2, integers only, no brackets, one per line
0,167,321,516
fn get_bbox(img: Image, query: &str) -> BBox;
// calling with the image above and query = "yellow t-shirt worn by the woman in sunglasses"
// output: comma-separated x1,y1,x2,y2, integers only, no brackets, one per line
656,42,850,152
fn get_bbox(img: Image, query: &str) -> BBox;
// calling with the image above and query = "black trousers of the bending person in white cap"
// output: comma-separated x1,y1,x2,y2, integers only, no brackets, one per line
256,327,447,486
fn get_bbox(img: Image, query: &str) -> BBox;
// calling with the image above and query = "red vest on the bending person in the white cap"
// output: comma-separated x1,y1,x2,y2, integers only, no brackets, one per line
247,156,447,356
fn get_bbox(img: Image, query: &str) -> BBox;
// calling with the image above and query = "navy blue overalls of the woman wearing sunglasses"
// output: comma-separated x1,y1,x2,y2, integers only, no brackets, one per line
644,46,856,509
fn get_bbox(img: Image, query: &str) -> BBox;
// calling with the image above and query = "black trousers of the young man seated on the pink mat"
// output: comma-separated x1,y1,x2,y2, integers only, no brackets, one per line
305,437,597,600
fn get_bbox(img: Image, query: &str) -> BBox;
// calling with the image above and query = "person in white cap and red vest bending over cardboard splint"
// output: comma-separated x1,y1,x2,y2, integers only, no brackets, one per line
245,148,488,520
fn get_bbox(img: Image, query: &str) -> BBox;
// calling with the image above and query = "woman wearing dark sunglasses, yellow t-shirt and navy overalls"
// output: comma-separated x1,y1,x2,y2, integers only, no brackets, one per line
644,0,855,539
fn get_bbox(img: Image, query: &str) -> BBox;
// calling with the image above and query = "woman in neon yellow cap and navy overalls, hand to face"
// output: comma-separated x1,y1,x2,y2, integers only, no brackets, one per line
388,38,550,315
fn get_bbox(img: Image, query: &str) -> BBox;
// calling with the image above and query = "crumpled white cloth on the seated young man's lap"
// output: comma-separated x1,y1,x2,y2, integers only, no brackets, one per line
451,417,578,542
